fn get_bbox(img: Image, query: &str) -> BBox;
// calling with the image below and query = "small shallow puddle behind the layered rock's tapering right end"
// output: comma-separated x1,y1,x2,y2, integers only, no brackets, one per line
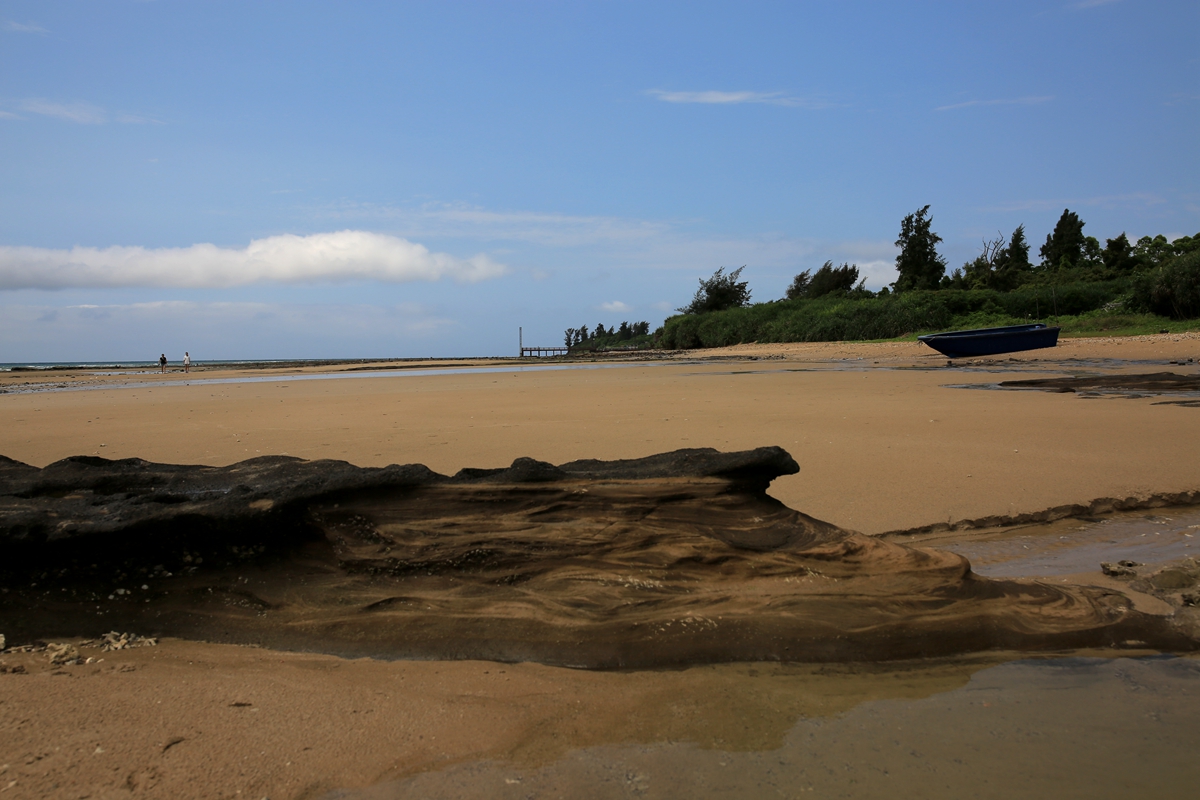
936,509,1200,578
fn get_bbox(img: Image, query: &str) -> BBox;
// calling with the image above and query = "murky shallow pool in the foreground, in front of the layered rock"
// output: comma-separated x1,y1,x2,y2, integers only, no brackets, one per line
325,657,1200,800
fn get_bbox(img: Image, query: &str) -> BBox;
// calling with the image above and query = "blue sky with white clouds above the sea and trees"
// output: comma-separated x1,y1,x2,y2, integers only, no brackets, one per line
0,0,1200,361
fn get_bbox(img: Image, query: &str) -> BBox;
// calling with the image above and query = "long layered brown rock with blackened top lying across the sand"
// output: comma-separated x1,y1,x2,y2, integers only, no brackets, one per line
0,447,1198,668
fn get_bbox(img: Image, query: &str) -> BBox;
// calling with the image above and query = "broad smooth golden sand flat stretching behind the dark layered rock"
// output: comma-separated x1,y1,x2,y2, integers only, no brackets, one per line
0,333,1200,534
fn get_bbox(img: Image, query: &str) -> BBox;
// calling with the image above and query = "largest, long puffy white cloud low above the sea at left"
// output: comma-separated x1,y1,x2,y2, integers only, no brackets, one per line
0,230,508,289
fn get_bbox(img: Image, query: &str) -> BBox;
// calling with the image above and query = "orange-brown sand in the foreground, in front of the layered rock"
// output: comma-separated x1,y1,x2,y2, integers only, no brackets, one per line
0,640,1012,798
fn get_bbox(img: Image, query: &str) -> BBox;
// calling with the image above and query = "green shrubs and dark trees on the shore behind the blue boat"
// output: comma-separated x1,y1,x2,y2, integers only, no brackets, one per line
654,205,1200,349
